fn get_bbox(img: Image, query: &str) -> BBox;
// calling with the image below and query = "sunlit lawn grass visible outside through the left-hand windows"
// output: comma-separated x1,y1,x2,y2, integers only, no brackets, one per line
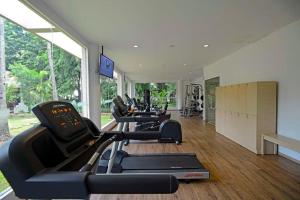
0,113,112,192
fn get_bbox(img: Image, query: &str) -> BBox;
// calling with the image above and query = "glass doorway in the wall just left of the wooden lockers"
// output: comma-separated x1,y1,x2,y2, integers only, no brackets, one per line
205,77,220,125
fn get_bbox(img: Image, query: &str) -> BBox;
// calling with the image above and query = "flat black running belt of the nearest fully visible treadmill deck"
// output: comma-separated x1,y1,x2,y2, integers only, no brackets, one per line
122,155,204,170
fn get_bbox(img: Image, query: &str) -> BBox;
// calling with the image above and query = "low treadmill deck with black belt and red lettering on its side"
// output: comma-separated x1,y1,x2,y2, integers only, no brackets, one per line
97,151,209,181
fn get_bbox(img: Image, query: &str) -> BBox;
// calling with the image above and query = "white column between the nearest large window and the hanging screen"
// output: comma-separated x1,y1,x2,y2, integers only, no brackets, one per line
81,44,101,129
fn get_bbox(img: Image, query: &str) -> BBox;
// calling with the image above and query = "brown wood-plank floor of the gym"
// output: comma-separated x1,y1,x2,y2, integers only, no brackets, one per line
92,113,300,200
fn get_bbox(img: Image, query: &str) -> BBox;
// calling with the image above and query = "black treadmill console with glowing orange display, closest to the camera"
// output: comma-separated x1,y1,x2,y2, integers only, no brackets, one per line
32,101,87,141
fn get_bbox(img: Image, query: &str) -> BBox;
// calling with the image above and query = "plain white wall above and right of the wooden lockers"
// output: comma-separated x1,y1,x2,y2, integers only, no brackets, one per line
204,20,300,160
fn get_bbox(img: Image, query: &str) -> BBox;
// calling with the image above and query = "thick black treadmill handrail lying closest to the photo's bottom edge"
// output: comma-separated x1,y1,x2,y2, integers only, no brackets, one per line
24,172,179,199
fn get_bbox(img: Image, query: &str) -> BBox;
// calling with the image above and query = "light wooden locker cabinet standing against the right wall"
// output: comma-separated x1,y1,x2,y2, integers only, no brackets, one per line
216,81,277,154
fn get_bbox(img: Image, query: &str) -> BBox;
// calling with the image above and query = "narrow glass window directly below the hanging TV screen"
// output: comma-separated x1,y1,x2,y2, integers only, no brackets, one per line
100,73,118,127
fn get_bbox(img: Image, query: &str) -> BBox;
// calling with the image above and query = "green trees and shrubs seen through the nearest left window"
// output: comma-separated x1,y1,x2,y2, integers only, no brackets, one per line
5,21,81,109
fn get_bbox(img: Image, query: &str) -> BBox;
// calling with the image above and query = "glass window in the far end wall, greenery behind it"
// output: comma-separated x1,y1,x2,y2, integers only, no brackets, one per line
135,83,176,108
